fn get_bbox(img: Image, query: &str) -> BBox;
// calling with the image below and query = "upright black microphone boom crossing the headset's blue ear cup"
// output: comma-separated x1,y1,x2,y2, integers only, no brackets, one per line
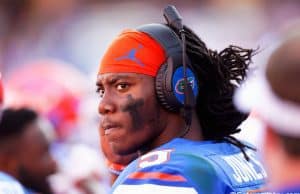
164,5,196,127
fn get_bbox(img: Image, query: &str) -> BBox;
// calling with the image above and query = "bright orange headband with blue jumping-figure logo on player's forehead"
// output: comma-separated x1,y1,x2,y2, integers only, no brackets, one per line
98,30,166,77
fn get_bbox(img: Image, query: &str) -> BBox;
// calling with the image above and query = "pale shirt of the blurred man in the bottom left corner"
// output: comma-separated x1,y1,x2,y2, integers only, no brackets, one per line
0,172,26,194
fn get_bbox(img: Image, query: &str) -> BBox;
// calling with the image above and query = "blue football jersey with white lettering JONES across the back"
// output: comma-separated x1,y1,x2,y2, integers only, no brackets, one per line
111,138,267,194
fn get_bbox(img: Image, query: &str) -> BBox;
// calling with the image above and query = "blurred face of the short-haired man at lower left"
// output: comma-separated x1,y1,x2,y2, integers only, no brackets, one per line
19,122,57,193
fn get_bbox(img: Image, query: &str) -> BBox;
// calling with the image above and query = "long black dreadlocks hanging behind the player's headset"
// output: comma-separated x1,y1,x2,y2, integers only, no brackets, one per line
173,26,255,160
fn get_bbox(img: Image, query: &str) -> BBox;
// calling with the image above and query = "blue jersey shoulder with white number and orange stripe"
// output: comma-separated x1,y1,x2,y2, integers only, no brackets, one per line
114,149,224,194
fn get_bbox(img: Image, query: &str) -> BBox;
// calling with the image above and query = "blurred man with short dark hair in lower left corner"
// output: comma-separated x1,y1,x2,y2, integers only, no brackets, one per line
0,108,56,194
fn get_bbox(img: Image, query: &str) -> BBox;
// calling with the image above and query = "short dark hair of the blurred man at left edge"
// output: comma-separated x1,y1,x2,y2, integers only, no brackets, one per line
0,108,38,142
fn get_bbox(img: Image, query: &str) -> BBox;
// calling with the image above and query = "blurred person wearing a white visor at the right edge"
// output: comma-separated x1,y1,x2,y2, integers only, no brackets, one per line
236,28,300,193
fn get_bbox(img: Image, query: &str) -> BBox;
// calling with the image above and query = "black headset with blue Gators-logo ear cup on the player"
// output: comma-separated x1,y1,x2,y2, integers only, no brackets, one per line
137,6,199,115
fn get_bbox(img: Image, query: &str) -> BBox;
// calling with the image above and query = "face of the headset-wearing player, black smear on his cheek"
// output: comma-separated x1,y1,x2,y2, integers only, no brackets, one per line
97,73,166,154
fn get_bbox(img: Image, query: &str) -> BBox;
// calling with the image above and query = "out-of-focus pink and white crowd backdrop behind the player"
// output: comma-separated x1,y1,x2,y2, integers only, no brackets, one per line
0,0,300,194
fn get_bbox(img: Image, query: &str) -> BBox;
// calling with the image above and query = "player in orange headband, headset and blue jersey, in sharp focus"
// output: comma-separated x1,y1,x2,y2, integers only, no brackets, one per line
97,7,266,194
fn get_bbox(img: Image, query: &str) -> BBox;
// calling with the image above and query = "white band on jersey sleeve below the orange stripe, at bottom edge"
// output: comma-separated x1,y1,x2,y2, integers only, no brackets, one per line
113,184,197,194
